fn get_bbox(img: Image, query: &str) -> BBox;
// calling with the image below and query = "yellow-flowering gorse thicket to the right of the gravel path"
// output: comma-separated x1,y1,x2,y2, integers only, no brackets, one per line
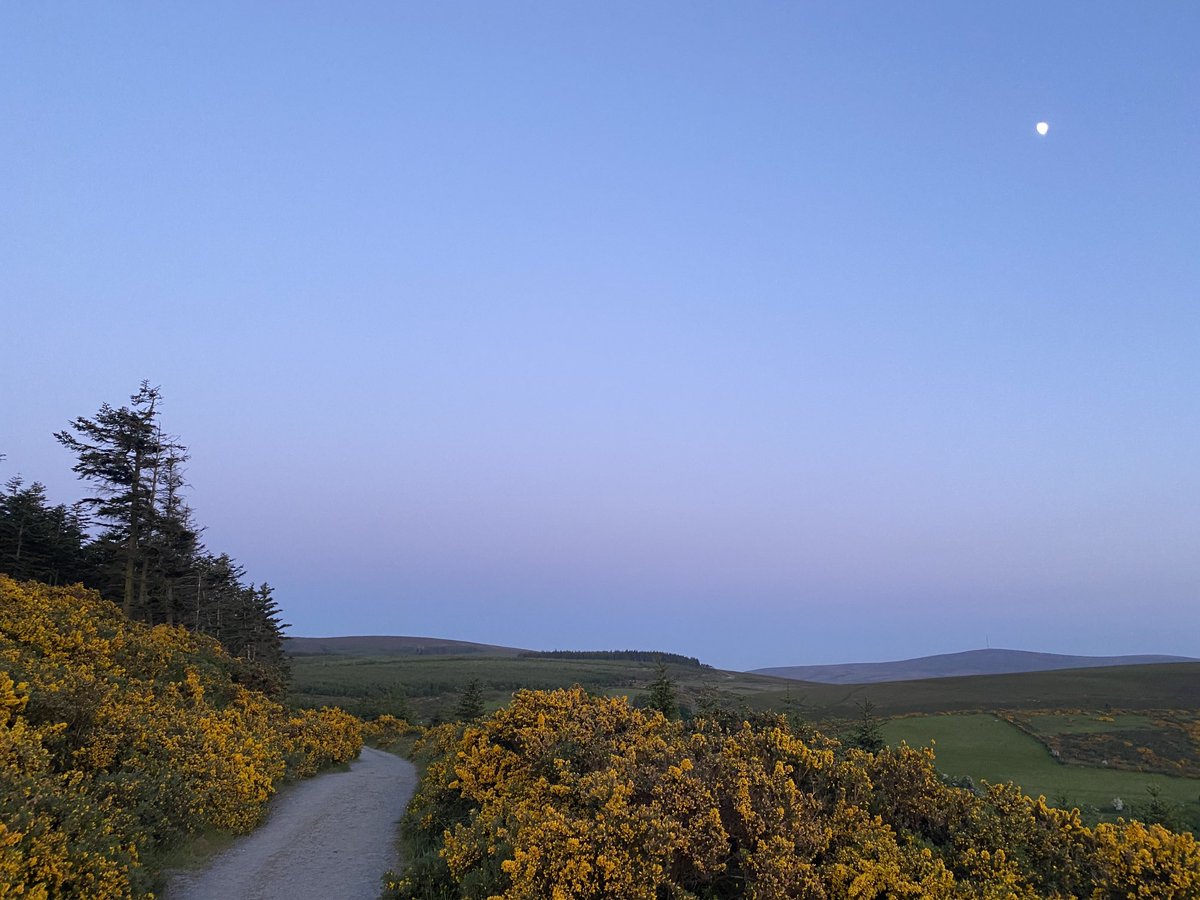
389,689,1200,900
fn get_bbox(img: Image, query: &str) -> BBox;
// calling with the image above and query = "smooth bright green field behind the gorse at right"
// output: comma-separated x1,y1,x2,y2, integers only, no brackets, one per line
883,714,1200,822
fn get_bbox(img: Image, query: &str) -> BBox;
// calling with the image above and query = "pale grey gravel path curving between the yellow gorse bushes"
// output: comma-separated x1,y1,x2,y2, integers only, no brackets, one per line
166,746,416,900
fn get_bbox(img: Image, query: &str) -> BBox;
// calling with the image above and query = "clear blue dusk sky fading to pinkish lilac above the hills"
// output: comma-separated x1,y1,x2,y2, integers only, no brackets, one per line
0,0,1200,668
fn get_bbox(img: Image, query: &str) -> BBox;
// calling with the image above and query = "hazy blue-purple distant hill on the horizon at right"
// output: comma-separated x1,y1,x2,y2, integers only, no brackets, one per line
751,649,1198,684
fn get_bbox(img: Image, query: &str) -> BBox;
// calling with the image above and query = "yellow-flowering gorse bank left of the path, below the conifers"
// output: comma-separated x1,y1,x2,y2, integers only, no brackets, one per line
0,575,362,898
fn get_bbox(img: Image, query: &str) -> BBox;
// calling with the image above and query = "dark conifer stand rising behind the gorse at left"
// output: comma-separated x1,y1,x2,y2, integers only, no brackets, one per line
0,382,287,692
